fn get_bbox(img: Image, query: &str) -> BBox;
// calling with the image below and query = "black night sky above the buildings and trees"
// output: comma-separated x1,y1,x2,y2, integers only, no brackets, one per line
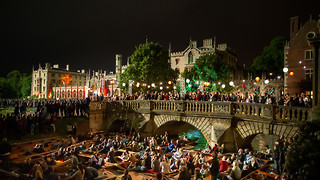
0,0,320,76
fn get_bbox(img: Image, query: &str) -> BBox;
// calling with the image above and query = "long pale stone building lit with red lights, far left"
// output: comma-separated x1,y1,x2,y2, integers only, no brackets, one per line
31,54,129,99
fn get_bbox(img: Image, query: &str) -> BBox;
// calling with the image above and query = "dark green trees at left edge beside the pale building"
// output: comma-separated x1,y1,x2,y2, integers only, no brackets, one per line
0,70,32,98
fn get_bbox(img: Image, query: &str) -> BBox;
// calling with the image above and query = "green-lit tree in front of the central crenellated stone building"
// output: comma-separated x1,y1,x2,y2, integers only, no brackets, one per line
182,54,233,92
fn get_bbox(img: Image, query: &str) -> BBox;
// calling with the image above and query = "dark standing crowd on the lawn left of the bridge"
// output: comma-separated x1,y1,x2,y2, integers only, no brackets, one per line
0,99,90,139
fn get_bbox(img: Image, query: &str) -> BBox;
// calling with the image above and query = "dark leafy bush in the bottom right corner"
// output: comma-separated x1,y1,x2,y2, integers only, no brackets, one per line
285,120,320,179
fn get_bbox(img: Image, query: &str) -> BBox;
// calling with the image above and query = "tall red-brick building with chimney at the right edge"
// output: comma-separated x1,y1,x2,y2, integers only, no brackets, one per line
284,16,320,95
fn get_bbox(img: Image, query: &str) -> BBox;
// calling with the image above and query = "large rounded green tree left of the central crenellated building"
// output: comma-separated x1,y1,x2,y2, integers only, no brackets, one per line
119,42,179,92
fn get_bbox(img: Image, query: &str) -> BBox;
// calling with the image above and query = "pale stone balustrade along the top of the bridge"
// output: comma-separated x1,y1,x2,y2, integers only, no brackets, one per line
90,100,312,121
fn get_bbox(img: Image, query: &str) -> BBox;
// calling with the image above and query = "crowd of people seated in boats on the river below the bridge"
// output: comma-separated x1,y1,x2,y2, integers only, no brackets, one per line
0,129,291,180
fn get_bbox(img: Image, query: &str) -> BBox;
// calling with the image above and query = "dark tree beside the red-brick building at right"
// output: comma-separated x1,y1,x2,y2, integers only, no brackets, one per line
250,36,287,74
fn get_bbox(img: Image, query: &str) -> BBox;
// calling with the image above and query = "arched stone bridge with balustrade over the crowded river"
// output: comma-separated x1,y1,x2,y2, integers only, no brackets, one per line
89,100,311,149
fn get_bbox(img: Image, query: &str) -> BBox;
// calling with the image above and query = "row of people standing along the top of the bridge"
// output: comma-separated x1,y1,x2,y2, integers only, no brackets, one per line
92,91,312,107
